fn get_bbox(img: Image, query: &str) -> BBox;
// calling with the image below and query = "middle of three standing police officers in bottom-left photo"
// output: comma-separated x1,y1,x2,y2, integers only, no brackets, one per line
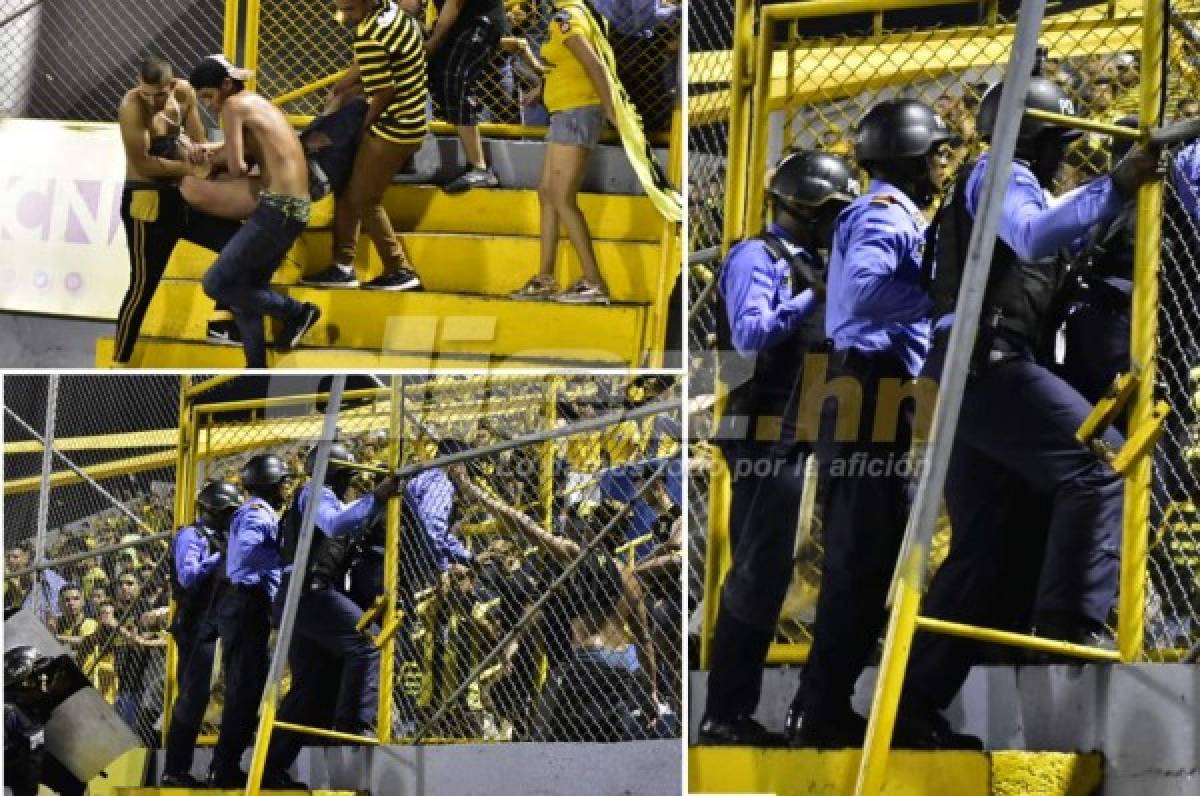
209,454,292,788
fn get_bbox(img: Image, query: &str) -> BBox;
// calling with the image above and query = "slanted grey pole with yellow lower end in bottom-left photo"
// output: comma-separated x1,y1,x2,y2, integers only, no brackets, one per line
246,373,346,796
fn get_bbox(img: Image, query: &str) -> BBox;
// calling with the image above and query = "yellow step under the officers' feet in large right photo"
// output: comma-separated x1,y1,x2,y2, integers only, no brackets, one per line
688,747,1104,796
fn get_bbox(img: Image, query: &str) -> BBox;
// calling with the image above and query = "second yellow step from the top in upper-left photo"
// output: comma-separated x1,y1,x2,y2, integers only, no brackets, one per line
166,229,674,304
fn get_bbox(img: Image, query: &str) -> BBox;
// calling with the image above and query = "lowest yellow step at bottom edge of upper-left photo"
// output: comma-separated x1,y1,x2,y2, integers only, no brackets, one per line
96,337,638,371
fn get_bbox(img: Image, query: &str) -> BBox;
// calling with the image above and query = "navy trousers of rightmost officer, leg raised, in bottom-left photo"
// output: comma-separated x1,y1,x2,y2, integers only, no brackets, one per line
266,588,379,772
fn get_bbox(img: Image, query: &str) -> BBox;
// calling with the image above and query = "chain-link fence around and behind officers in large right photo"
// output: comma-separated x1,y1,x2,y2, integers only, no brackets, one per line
689,0,1200,660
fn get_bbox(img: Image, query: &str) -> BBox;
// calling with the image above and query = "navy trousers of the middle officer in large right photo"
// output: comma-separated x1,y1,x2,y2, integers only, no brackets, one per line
793,351,912,722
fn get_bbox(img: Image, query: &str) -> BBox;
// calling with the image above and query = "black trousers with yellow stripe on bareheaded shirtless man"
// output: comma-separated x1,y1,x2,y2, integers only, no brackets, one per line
113,181,241,363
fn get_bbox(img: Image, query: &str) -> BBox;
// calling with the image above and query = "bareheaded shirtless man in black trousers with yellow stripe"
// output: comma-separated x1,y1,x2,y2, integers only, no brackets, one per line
113,55,236,365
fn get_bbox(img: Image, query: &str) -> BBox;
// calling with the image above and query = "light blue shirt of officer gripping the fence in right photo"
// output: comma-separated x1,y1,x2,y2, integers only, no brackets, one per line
937,155,1124,329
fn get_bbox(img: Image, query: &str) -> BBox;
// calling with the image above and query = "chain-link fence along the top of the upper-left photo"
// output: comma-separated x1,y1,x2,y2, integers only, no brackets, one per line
0,0,683,142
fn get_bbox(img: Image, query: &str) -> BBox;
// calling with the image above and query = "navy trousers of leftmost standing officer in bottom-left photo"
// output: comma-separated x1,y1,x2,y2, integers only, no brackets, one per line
163,617,218,774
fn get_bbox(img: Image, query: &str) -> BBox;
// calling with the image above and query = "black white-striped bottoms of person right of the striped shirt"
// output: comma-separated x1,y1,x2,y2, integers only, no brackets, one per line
430,17,502,126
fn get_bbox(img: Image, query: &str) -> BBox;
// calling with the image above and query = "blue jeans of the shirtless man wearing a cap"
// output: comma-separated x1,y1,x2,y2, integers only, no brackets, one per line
204,202,306,367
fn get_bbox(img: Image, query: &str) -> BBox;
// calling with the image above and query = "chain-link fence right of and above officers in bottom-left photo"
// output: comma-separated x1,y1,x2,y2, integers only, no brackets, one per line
178,376,683,742
